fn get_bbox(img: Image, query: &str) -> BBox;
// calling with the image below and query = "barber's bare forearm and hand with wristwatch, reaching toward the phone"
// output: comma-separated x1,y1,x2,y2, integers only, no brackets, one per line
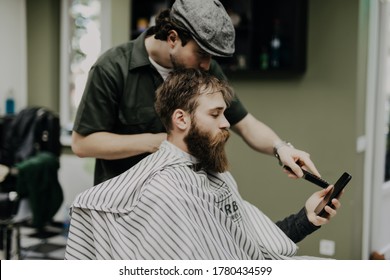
232,114,320,178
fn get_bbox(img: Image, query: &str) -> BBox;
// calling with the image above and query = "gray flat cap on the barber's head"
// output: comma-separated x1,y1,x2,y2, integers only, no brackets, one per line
171,0,235,56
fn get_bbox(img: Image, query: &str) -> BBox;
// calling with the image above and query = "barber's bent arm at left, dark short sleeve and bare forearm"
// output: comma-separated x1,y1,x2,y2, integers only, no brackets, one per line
72,64,166,160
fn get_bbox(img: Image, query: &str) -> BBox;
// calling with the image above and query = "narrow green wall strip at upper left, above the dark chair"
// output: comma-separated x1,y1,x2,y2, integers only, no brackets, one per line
26,0,61,112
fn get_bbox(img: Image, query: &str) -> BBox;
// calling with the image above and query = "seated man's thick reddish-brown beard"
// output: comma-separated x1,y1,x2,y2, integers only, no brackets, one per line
184,123,230,173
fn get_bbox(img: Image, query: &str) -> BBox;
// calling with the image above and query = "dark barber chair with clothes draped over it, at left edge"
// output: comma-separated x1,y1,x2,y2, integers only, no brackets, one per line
0,108,64,259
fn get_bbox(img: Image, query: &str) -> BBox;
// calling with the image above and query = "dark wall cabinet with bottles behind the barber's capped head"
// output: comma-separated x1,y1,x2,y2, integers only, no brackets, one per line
131,0,308,78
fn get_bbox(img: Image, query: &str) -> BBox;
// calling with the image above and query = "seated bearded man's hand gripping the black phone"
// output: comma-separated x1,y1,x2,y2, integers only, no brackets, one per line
305,185,344,226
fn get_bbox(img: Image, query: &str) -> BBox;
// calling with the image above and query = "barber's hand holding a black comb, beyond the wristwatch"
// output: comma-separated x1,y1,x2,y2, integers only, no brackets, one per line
278,145,321,178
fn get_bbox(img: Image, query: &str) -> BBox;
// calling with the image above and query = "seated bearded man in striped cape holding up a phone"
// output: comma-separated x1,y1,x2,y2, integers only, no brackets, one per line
65,69,340,260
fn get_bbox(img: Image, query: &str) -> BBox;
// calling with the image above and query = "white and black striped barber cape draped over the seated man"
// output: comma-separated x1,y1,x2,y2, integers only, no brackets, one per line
65,141,297,260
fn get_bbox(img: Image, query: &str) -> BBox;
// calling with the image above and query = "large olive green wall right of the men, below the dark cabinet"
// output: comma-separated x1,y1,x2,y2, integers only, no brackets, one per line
225,0,362,259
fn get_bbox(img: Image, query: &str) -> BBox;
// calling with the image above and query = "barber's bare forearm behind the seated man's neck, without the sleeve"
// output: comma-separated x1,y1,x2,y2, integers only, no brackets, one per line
72,131,167,160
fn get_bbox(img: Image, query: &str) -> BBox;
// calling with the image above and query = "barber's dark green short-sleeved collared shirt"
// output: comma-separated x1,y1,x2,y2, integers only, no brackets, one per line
73,31,247,184
